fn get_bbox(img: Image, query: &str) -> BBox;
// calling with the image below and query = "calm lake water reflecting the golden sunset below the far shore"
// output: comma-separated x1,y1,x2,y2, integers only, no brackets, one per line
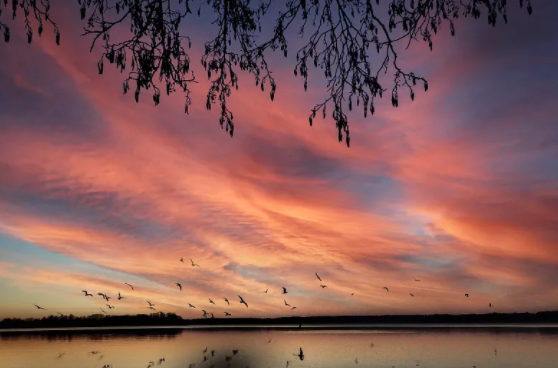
0,327,558,368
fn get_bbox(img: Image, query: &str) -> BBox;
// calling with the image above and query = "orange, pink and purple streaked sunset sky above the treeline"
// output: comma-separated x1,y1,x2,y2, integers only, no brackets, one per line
0,0,558,318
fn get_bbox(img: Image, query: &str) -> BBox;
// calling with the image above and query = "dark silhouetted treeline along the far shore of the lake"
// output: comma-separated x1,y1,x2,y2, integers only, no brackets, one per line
0,311,558,329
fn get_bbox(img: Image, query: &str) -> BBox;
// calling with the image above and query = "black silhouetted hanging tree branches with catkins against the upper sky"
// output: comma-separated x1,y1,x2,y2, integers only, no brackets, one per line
0,0,532,146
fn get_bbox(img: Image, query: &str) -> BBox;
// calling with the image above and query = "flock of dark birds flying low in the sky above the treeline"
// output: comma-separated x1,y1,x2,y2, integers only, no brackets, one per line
31,258,492,318
